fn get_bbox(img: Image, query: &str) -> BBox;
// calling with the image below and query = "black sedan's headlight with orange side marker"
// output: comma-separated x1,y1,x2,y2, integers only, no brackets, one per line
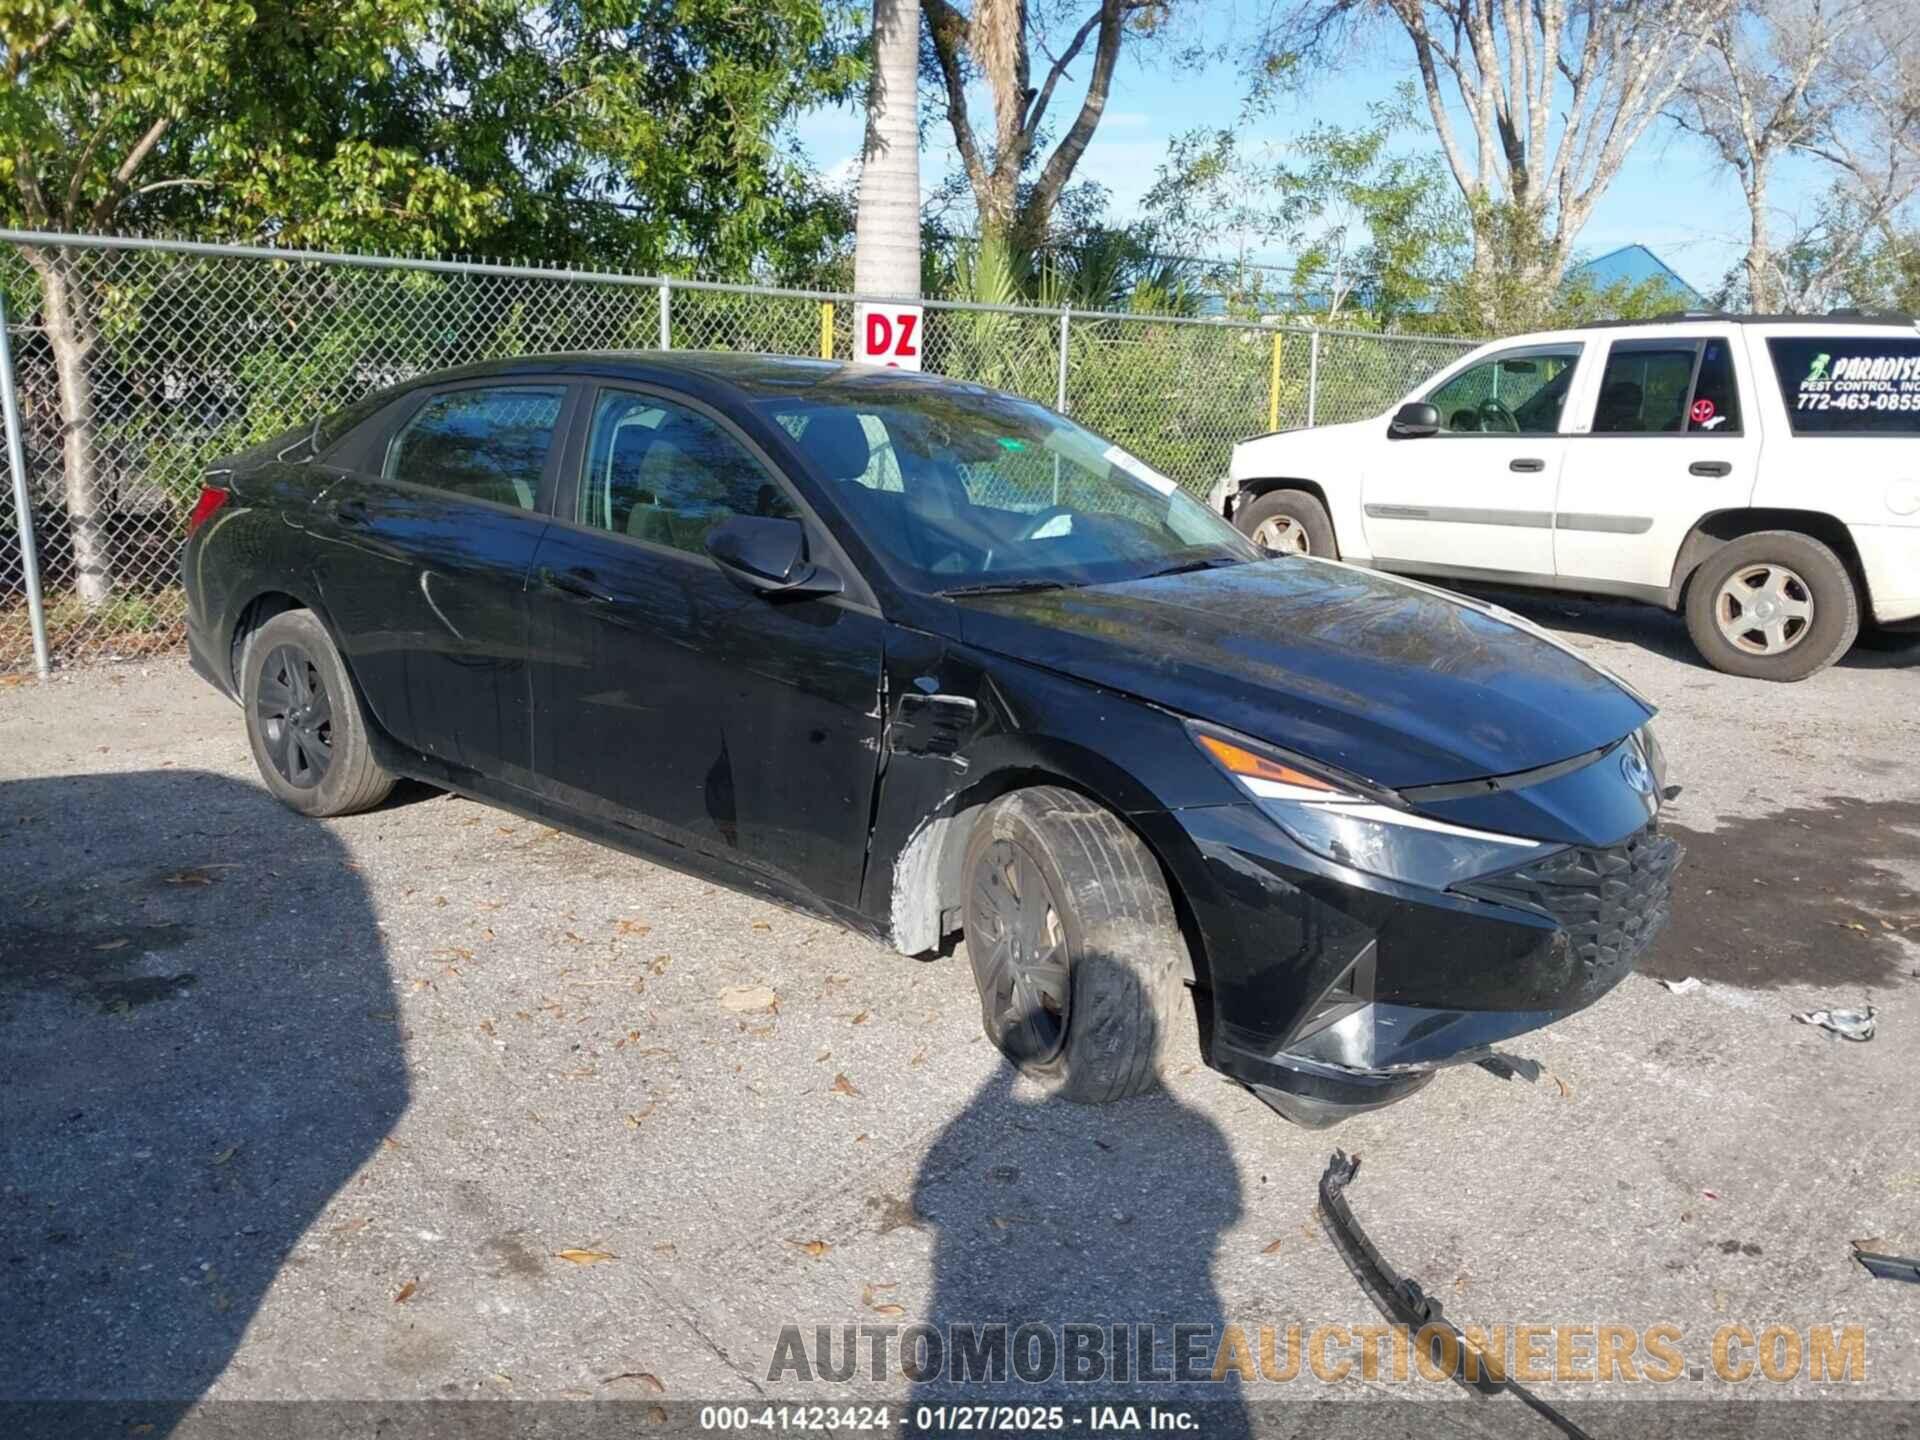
1188,726,1565,891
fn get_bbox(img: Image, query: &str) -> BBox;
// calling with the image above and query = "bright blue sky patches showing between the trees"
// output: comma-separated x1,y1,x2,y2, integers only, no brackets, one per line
799,12,1820,294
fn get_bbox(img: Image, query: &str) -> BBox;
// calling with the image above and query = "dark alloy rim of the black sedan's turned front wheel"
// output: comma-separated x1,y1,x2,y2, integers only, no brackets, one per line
968,839,1073,1066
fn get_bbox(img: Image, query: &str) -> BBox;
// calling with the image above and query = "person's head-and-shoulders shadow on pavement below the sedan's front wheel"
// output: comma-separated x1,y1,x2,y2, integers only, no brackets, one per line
910,956,1250,1440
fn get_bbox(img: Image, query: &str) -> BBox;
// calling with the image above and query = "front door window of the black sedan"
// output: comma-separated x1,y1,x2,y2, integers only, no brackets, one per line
574,390,799,555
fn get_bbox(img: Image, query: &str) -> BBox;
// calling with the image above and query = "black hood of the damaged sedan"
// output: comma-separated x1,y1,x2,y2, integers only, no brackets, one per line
960,559,1653,789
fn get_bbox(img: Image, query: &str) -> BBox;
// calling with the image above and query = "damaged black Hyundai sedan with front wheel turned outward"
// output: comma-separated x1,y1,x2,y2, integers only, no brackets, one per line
184,353,1680,1125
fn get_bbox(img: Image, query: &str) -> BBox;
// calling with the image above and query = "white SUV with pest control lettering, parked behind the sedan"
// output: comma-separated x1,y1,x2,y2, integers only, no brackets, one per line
1221,315,1920,680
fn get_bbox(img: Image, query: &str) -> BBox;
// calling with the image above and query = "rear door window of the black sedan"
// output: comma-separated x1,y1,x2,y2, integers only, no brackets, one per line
382,386,566,511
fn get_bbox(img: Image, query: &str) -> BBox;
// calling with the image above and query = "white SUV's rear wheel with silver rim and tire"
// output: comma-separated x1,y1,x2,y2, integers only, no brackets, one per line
1686,530,1860,680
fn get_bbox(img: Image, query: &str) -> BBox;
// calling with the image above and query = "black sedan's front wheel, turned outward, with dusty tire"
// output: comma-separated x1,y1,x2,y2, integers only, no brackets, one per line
964,785,1185,1104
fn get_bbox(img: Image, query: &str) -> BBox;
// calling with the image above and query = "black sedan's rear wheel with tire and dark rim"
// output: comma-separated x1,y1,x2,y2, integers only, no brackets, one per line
240,611,394,816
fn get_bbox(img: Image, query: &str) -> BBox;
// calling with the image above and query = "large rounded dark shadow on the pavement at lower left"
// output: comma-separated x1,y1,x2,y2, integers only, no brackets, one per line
0,770,407,1440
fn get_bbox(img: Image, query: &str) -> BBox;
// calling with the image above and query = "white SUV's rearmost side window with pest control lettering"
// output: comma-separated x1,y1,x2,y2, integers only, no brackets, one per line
1766,337,1920,436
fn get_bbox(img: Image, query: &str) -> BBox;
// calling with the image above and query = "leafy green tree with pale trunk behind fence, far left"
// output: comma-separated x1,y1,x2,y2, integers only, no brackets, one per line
0,0,492,605
